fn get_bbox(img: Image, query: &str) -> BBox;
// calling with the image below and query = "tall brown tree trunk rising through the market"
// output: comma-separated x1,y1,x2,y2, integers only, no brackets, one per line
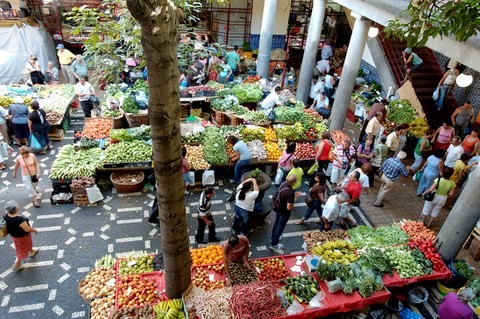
127,0,191,298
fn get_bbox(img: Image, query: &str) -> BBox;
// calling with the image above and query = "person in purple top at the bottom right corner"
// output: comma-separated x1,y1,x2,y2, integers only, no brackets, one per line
438,288,475,319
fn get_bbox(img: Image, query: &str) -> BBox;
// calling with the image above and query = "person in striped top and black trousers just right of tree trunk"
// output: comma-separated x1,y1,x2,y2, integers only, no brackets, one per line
195,186,220,244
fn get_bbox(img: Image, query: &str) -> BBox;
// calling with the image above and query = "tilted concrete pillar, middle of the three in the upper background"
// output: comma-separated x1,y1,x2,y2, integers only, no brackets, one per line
297,0,327,103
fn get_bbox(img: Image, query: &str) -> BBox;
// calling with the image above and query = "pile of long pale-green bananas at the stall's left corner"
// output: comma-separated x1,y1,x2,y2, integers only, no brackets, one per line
50,145,103,179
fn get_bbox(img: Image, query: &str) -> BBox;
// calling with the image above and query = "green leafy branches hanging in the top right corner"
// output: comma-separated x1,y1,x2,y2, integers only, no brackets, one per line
384,0,480,47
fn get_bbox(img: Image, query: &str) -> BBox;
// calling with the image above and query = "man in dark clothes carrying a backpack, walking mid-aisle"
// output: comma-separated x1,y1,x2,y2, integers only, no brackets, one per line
268,175,301,254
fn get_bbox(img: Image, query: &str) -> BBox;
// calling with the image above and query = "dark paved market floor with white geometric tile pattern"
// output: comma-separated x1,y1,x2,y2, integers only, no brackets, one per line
0,111,478,319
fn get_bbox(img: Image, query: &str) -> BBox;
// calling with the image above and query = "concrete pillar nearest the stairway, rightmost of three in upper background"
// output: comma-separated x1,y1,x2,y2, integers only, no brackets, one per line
329,11,370,130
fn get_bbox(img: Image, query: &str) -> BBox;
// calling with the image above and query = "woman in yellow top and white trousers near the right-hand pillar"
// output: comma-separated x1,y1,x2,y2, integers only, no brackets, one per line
422,169,456,228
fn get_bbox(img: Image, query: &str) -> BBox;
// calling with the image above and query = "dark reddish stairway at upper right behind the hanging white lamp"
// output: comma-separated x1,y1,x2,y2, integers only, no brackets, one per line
380,32,458,129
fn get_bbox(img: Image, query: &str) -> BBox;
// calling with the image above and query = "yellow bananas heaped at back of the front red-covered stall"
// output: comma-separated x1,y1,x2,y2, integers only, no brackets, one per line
312,240,358,265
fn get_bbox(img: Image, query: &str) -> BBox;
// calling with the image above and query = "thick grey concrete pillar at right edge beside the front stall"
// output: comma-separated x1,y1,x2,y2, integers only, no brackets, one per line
435,167,480,262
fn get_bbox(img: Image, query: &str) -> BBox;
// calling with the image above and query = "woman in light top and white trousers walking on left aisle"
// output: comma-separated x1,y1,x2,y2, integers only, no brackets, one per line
13,146,40,208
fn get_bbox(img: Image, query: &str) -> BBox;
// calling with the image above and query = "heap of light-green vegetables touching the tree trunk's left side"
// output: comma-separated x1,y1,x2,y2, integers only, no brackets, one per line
103,141,152,163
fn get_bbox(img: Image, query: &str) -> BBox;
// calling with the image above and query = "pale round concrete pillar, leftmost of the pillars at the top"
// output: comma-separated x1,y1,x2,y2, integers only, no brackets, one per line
257,0,277,78
